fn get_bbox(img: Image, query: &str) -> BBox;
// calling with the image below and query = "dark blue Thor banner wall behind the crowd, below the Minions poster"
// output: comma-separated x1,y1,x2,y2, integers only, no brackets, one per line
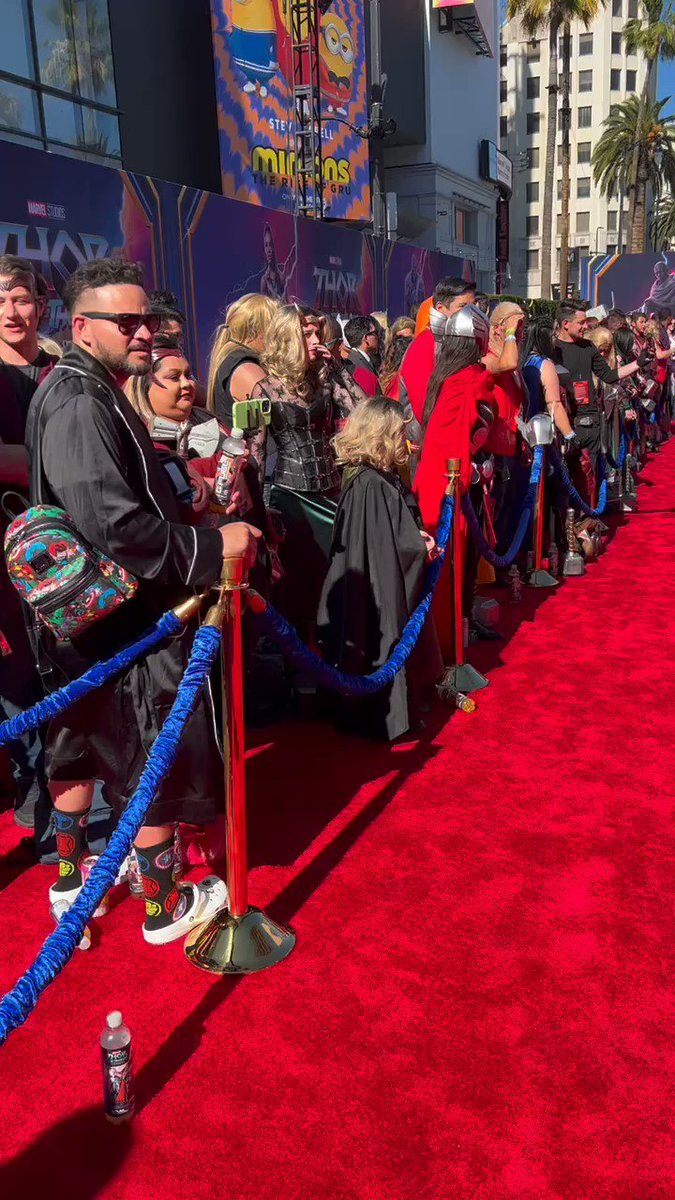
0,142,468,373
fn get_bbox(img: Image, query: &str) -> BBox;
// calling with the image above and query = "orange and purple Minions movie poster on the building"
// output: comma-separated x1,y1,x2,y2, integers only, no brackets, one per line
211,0,370,221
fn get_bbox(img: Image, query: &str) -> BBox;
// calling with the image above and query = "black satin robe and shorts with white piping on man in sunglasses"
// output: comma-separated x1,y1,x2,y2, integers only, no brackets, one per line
26,347,222,824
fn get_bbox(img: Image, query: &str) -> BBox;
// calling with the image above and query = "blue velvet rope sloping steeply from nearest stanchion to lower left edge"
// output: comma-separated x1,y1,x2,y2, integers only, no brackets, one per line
0,625,221,1045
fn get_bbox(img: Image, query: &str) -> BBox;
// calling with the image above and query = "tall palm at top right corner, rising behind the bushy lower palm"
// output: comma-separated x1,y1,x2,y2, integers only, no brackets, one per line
621,0,675,254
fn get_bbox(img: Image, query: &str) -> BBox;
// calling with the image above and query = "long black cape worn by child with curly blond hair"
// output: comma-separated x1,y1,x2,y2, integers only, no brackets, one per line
317,467,442,740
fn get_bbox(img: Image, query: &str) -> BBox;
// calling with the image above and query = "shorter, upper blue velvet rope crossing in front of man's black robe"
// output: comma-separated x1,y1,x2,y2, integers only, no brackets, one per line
0,612,184,746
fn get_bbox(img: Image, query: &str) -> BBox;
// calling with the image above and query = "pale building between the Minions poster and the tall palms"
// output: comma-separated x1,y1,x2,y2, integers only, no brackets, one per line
382,0,500,292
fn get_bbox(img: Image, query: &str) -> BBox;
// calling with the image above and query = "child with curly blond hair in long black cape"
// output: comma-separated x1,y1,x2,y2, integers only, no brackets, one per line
317,396,443,742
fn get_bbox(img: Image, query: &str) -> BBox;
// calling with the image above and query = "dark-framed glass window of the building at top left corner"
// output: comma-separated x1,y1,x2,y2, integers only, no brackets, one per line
0,0,121,164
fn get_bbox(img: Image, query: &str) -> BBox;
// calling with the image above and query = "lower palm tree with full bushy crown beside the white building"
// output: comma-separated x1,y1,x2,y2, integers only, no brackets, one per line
593,96,675,252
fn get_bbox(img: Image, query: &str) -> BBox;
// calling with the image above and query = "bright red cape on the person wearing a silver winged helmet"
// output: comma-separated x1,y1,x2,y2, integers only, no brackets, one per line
414,364,497,533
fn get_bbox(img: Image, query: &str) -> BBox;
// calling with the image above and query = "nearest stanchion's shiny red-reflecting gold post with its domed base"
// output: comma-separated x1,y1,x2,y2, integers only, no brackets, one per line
185,558,295,974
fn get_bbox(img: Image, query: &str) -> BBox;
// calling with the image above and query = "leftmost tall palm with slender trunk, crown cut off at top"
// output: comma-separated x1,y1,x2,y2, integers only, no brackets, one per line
507,0,604,300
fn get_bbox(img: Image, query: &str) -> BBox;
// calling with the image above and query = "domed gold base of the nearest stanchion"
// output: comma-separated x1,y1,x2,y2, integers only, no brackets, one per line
185,908,295,974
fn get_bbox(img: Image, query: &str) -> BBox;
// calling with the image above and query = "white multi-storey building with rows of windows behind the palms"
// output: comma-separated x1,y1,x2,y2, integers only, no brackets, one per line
500,0,656,298
